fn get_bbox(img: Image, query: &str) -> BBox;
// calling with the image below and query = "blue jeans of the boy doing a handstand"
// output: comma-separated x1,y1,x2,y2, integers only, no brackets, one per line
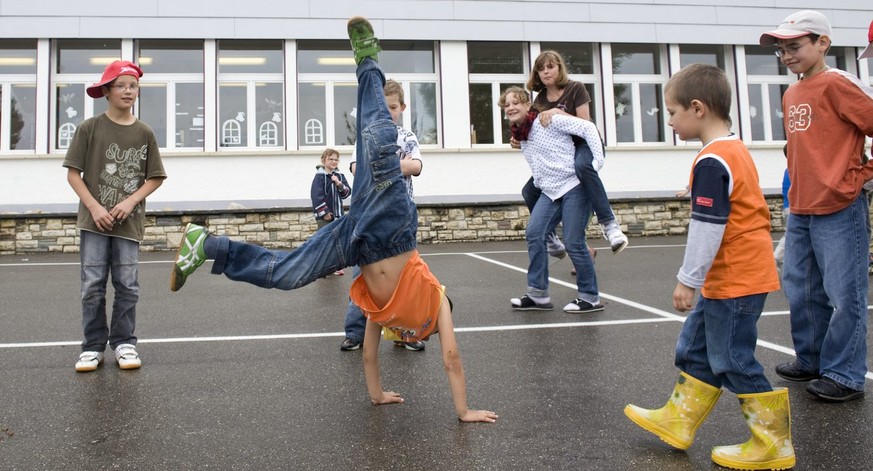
205,59,418,290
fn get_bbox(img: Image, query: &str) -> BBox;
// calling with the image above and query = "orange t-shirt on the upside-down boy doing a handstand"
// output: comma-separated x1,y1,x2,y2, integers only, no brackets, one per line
349,250,445,342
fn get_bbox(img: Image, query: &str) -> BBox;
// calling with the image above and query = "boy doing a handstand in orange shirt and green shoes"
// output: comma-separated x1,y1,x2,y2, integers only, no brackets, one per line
170,17,497,422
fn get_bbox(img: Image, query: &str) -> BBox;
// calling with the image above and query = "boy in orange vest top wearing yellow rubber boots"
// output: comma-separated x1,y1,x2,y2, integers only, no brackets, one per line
624,64,795,469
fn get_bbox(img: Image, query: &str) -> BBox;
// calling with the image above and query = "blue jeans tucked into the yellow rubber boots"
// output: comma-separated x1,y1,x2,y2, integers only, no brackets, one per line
676,293,773,394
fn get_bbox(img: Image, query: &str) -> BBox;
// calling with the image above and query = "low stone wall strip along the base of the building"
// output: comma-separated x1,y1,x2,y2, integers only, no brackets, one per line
0,196,783,255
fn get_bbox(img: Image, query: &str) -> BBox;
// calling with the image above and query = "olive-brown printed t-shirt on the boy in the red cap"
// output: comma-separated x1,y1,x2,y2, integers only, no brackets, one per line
63,113,167,242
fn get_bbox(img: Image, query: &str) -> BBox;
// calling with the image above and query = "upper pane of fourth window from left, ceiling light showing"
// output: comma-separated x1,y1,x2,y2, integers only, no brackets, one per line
218,39,284,74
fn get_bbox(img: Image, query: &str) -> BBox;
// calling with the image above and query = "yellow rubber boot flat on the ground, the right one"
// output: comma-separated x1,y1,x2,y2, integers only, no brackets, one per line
712,388,795,469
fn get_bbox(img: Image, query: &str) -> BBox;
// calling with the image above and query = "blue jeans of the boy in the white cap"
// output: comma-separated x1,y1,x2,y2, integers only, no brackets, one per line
782,194,870,391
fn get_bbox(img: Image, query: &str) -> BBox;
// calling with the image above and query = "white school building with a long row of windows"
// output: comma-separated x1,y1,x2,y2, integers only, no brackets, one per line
0,0,873,213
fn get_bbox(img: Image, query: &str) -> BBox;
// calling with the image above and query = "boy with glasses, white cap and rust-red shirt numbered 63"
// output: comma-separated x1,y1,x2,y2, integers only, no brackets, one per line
759,10,873,402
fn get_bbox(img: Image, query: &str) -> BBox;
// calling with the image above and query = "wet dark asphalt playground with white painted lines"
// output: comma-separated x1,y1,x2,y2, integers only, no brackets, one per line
0,235,873,471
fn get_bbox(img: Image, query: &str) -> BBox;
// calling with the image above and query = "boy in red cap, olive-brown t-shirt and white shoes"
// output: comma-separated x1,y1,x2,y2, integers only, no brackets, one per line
63,61,167,371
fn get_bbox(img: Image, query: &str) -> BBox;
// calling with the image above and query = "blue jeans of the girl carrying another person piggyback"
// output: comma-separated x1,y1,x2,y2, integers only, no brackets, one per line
525,185,600,304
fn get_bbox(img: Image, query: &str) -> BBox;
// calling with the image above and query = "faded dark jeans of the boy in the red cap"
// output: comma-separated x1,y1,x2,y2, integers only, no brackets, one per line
79,231,139,352
